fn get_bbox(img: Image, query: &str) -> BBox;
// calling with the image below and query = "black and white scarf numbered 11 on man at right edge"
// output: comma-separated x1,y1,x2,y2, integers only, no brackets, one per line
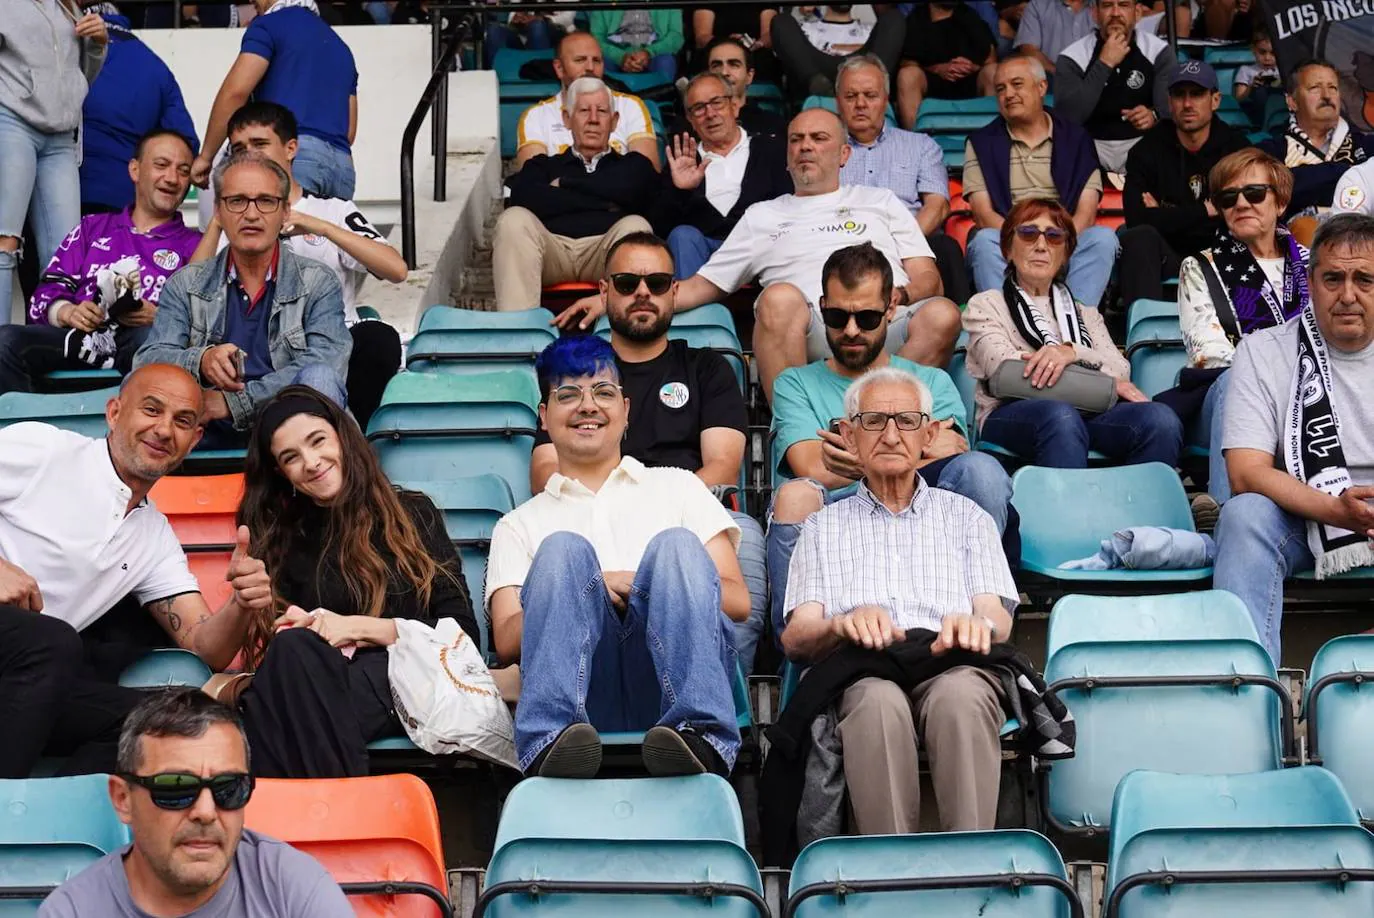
1283,306,1374,580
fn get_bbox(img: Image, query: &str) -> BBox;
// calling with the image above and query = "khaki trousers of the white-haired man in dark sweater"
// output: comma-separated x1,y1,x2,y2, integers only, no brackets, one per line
492,208,653,311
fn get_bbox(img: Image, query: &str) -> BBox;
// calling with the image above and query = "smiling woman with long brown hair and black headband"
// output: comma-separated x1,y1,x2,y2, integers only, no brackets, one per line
230,386,480,778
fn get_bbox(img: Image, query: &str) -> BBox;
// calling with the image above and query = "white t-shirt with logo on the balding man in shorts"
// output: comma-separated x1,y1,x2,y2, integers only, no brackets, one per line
699,186,934,308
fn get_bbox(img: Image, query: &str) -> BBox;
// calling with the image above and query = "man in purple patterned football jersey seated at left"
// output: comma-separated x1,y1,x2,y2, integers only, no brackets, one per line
0,129,201,393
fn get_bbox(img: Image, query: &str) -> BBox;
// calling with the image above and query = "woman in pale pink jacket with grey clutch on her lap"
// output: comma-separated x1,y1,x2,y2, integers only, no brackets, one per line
963,199,1183,469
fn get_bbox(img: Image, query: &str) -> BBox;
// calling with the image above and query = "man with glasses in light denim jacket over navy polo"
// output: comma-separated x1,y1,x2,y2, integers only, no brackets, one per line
133,150,353,449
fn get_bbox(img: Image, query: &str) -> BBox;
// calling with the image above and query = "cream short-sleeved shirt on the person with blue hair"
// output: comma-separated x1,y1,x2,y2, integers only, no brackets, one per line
486,456,739,609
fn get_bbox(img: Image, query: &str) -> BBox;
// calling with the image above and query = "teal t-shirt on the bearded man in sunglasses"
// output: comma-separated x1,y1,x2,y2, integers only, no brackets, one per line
772,356,969,478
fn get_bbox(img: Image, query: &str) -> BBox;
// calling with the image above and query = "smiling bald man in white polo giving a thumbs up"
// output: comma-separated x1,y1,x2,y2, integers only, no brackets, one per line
0,364,272,778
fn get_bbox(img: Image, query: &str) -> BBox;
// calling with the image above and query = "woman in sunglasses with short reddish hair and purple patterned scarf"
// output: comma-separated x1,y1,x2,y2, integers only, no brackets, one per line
1168,147,1308,510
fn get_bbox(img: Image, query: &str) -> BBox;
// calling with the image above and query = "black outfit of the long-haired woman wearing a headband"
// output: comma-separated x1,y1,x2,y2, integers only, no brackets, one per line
240,492,480,778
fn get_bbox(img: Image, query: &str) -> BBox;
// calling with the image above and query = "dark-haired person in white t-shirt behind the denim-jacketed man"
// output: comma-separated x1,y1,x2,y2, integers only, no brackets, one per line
195,102,408,430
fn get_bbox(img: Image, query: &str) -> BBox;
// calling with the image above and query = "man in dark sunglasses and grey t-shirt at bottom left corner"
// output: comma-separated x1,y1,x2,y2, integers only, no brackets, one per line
38,689,353,918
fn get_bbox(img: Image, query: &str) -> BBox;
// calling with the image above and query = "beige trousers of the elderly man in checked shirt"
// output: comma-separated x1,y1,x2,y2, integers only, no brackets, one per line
838,667,1006,836
